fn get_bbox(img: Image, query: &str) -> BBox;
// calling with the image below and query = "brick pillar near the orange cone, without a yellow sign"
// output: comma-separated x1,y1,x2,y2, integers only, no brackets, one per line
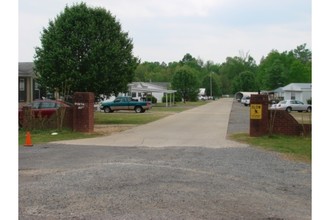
73,92,94,133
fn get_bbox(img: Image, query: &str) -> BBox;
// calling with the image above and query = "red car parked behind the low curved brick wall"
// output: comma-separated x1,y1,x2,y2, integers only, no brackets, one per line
18,99,72,125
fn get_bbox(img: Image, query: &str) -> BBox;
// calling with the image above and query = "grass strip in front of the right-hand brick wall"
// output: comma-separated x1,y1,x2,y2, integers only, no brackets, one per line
230,133,312,163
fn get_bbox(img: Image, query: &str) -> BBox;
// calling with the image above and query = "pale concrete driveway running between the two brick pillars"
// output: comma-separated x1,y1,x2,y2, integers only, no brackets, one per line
56,98,246,148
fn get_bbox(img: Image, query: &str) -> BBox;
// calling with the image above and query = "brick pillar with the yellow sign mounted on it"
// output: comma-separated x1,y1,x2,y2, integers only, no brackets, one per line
250,95,268,137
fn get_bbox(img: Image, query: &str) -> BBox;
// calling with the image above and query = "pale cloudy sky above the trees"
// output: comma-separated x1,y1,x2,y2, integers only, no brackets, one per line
18,0,312,63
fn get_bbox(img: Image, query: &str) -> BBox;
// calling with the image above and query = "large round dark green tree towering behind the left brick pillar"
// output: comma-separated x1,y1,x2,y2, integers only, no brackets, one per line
34,3,138,95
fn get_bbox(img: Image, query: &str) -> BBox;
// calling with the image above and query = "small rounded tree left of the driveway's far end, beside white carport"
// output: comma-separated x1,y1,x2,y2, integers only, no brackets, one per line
172,65,199,102
